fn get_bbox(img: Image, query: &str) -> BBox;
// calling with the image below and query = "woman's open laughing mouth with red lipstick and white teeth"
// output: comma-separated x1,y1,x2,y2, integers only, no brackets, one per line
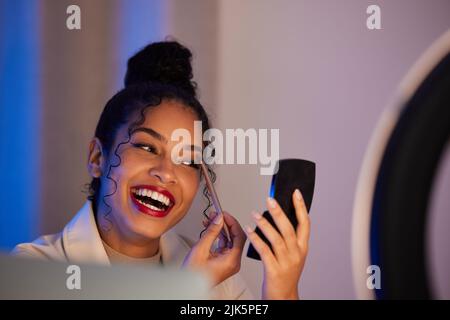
130,185,175,218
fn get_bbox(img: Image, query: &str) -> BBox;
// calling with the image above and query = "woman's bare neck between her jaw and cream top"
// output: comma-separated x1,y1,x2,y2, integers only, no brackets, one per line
96,209,160,258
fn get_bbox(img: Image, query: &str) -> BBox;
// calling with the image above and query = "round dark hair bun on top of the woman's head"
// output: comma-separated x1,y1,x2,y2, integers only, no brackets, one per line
124,41,197,96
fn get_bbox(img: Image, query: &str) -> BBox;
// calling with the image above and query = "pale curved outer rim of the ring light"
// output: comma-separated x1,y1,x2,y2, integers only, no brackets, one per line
351,30,450,299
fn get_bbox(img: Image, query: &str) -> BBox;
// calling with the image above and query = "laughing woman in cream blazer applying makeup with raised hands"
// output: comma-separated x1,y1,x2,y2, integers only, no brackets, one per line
13,42,309,299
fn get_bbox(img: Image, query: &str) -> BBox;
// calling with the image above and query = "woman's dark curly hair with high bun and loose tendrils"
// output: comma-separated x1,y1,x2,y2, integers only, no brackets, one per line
88,41,216,232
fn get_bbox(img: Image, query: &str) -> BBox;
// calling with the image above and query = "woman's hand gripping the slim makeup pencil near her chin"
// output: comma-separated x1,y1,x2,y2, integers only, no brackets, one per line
183,212,246,286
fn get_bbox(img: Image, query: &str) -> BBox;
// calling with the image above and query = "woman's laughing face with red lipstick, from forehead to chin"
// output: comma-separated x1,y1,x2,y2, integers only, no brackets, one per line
98,101,201,240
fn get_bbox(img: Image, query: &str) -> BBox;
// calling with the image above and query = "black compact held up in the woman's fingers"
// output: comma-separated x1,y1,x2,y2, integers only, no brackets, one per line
247,159,316,260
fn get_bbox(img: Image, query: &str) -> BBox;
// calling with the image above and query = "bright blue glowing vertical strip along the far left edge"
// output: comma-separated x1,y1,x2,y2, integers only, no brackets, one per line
0,0,41,249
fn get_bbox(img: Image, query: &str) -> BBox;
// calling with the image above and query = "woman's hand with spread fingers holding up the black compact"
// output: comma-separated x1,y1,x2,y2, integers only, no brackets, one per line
246,190,310,300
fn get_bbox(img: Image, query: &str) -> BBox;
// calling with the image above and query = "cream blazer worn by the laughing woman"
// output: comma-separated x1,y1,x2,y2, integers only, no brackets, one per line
12,201,253,300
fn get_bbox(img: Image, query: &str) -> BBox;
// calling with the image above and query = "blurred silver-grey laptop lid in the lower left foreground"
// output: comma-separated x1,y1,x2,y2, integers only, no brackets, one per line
0,254,209,300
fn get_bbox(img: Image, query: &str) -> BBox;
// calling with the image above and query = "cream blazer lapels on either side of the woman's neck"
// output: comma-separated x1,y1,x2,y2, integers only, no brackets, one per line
62,200,190,267
